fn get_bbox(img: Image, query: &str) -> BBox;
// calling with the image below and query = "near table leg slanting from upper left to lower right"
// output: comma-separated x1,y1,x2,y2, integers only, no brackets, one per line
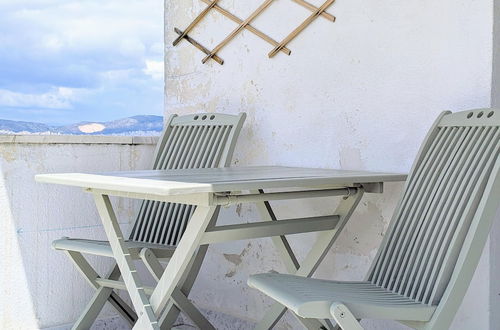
94,193,160,330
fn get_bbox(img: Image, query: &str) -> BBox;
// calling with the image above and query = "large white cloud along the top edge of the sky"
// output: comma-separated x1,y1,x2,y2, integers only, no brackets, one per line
8,0,163,56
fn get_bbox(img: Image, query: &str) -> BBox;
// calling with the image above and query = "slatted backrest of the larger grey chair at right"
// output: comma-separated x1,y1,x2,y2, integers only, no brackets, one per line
368,109,500,305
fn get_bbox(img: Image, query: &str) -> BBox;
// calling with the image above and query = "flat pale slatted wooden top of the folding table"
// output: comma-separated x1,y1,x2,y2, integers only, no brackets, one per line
36,166,406,195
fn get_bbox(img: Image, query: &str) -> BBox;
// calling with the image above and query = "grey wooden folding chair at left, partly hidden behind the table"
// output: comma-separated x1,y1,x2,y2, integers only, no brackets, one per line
53,113,246,329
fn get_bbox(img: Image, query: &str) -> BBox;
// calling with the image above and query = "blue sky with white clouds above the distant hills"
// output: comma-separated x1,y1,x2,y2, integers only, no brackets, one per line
0,0,163,124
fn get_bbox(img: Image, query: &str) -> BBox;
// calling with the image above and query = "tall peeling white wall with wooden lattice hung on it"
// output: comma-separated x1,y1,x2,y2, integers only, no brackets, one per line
165,0,495,329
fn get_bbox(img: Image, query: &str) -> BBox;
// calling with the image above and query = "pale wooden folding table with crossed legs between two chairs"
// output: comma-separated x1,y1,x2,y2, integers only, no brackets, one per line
36,166,406,329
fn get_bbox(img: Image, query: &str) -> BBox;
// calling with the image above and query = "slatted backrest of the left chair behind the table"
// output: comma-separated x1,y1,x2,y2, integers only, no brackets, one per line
129,113,245,245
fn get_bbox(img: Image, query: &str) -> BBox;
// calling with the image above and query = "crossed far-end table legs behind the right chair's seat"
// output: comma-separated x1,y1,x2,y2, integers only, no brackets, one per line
256,188,364,329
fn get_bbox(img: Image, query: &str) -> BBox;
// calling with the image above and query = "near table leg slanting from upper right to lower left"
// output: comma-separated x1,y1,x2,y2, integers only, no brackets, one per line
140,206,216,329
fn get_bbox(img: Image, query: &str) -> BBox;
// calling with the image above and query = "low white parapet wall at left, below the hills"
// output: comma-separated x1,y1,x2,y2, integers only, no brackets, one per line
0,137,155,330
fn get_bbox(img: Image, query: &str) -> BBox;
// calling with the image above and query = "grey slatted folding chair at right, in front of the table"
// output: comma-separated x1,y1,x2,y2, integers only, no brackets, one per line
248,109,500,330
